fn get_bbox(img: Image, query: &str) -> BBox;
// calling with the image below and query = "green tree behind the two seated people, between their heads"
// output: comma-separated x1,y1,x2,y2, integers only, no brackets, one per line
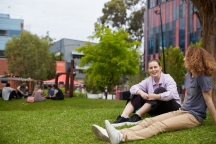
160,46,186,86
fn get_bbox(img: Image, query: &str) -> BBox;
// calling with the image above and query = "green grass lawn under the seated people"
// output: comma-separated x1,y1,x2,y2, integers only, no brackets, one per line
0,97,216,144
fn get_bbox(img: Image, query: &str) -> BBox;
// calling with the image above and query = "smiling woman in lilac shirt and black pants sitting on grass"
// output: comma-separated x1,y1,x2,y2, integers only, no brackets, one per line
112,59,181,127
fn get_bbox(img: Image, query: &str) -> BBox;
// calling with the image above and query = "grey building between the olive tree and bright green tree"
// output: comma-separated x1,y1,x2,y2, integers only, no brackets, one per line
50,38,95,82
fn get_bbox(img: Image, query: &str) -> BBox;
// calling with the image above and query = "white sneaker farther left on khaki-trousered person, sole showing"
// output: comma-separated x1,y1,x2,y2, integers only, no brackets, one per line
92,124,110,142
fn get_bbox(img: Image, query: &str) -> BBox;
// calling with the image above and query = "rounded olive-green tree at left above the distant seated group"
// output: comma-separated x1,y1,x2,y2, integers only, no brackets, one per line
4,31,52,80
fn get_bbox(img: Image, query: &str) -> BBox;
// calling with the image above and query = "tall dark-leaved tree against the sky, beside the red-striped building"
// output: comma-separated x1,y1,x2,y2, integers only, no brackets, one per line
97,0,145,41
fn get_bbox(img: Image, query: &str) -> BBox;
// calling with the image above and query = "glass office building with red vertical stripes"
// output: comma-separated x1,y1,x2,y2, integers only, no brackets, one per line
144,0,201,71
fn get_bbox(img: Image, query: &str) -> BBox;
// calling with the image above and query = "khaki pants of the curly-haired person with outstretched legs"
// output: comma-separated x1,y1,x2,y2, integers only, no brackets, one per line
120,110,201,142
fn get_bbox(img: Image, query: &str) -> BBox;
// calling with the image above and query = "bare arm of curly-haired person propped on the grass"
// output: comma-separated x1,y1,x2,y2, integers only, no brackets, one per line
203,90,216,124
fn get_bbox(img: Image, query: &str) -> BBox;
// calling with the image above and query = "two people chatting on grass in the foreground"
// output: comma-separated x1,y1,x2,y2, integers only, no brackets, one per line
92,46,216,144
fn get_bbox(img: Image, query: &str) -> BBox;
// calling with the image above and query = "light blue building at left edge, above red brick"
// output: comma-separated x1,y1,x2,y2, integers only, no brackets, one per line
0,14,24,57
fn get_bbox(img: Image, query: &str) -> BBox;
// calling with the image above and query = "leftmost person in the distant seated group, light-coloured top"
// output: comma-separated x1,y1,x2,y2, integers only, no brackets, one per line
2,83,17,100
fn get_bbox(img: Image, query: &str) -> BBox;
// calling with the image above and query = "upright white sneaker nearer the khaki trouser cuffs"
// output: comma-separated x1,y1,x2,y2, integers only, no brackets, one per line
105,120,122,144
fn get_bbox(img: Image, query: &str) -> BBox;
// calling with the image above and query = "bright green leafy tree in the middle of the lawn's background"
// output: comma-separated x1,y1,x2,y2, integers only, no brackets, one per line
77,24,140,98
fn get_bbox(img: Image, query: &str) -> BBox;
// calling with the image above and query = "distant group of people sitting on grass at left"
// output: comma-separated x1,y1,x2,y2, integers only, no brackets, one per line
2,81,64,102
